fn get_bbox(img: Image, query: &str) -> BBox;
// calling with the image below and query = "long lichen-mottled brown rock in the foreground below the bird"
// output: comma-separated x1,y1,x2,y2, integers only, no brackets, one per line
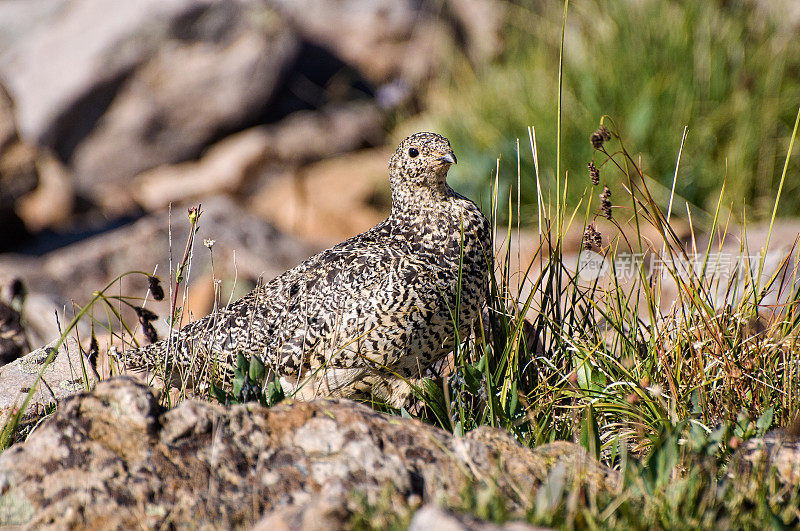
0,378,618,529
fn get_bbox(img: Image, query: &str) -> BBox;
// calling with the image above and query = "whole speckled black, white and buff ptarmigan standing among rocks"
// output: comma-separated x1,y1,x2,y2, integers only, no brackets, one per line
123,133,492,405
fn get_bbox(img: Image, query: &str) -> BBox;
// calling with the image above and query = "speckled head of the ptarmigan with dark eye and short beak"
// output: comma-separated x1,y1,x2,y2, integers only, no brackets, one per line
389,133,456,200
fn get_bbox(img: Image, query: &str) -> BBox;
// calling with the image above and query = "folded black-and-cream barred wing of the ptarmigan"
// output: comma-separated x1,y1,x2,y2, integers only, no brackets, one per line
265,245,434,373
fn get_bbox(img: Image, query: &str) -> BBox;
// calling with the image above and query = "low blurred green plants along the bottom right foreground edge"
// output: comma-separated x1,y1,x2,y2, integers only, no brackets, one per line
350,415,800,529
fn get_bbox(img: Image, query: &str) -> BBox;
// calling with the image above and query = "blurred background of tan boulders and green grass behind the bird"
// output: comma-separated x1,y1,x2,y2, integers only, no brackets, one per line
0,0,800,362
